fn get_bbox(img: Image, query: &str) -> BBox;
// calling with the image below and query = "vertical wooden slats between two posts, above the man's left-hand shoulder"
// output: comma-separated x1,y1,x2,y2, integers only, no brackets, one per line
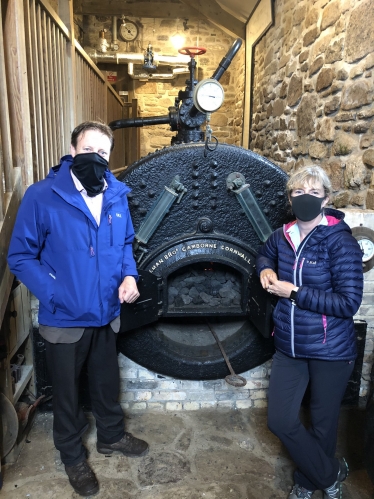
25,0,70,182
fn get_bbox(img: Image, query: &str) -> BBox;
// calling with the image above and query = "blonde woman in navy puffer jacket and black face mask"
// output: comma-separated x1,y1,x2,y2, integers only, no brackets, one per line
256,166,363,499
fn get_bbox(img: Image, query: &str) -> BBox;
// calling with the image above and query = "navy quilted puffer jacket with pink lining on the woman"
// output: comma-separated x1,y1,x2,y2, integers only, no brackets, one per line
256,209,363,360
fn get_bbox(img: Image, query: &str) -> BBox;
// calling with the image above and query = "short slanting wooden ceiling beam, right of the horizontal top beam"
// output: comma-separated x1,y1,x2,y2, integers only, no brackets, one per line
179,0,245,40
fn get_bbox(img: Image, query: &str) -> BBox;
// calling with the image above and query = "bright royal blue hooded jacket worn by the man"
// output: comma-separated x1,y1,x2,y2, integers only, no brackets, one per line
8,155,138,327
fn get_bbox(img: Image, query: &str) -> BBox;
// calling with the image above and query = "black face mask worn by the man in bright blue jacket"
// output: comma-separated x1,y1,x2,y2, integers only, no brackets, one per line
71,152,108,198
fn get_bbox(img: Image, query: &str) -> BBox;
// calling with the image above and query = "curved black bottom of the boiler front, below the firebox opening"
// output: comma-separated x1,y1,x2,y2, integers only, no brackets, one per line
118,316,274,380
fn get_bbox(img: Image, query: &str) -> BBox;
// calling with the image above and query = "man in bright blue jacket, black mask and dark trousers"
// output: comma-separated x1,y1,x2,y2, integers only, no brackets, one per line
8,121,148,496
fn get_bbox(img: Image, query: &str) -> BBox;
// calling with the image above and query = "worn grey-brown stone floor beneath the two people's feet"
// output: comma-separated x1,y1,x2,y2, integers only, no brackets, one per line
0,408,374,499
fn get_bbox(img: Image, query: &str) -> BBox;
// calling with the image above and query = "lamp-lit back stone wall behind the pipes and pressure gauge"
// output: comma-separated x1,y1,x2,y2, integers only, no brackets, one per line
79,16,245,156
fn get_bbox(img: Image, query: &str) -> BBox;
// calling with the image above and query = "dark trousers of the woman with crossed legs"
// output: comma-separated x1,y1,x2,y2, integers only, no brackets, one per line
268,352,354,490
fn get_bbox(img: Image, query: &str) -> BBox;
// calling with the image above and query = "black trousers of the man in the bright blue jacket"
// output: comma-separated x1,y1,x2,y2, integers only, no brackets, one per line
45,325,124,466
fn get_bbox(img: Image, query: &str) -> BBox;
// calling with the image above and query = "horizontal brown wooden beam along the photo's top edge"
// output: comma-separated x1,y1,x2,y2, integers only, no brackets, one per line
74,0,199,19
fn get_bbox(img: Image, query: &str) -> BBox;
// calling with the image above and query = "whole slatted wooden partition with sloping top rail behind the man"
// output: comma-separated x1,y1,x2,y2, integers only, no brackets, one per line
0,0,125,324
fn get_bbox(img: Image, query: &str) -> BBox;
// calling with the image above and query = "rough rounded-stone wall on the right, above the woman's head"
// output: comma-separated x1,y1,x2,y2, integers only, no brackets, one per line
251,0,374,209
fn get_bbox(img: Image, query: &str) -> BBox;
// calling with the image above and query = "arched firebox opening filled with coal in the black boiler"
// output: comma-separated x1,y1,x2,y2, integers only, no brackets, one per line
164,261,247,316
